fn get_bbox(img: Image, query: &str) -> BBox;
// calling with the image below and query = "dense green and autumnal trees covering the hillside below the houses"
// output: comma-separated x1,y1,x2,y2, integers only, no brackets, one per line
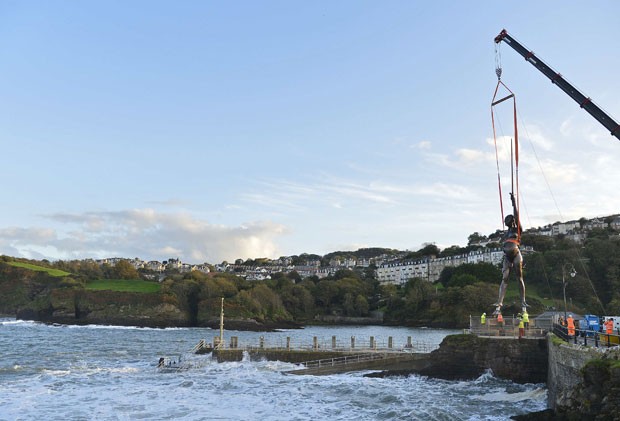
0,226,620,327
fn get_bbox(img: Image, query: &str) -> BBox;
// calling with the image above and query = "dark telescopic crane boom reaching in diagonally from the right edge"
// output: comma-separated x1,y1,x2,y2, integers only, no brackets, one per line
495,29,620,140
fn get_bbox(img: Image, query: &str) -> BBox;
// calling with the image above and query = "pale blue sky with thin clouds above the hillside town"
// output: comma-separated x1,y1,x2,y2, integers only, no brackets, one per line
0,0,620,263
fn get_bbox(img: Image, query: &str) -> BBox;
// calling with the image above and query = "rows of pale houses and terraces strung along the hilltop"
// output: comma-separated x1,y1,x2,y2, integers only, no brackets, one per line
96,215,620,285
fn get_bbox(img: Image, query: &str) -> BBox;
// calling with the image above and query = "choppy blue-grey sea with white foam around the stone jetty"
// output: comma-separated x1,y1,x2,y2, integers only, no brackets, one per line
0,318,547,421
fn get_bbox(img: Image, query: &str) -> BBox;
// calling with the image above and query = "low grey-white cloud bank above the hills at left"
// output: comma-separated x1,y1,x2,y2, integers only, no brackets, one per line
0,209,287,263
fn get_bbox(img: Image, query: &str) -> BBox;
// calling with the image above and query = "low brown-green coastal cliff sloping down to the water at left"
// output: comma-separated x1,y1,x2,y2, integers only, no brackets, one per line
0,263,299,331
